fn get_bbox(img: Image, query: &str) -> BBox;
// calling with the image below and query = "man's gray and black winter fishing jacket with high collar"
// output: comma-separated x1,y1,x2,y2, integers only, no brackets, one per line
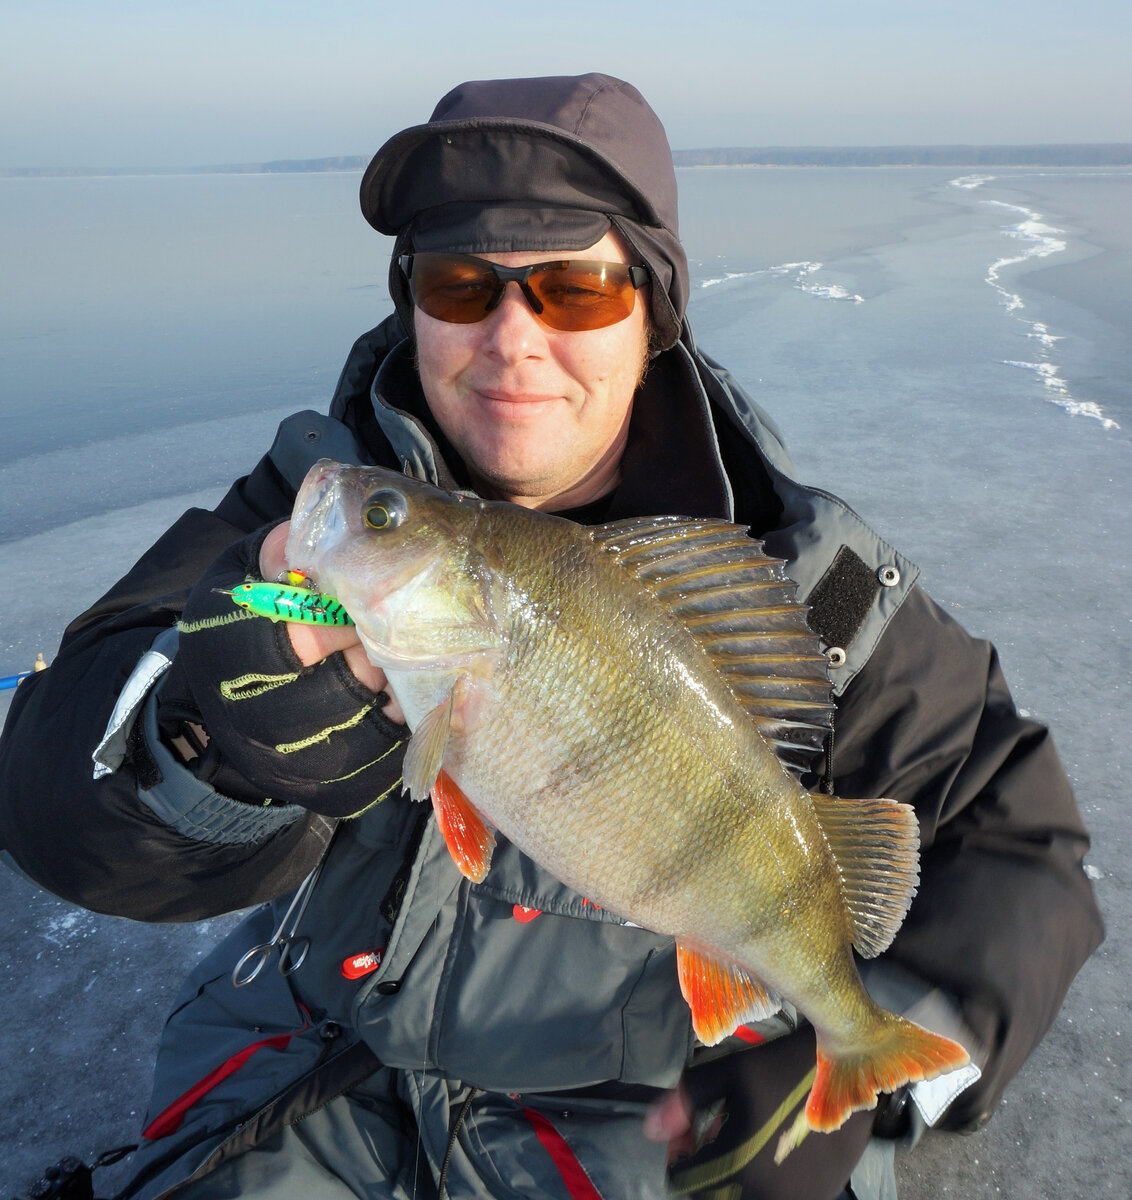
0,320,1101,1195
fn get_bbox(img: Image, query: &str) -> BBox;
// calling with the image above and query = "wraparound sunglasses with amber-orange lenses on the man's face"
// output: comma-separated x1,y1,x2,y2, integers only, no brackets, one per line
397,252,648,332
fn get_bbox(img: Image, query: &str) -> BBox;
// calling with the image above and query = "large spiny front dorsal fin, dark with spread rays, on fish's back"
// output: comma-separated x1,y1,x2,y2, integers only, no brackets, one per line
589,517,833,770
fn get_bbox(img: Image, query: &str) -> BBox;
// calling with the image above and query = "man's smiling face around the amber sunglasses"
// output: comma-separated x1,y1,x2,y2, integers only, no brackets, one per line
413,234,648,510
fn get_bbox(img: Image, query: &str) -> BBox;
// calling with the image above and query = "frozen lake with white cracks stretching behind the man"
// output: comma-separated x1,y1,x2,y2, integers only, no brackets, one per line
0,168,1132,1200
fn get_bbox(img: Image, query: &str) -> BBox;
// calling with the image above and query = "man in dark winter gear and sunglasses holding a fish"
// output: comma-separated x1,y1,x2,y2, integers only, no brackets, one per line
0,74,1101,1200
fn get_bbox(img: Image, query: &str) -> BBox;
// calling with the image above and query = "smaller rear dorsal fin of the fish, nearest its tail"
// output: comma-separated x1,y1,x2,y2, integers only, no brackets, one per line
811,793,920,959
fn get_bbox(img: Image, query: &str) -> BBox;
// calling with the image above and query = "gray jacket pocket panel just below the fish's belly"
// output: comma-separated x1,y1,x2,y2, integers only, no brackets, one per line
433,868,690,1092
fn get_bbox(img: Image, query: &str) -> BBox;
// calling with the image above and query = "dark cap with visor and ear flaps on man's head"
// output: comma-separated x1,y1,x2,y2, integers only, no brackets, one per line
361,73,688,349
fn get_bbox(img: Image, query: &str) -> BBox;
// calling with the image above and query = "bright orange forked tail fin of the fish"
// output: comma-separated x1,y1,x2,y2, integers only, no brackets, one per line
805,1013,968,1133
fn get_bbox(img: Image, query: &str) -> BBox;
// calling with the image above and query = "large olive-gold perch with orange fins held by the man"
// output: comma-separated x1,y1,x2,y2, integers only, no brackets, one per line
286,460,968,1135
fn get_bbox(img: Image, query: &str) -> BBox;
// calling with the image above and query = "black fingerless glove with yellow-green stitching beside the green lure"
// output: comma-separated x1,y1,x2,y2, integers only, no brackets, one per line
157,529,408,817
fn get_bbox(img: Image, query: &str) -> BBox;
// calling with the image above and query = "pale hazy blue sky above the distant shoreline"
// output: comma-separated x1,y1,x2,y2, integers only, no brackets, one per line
0,0,1132,168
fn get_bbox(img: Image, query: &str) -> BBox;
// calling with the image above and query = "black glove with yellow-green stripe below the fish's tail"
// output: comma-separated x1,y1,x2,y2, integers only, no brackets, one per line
669,1025,873,1200
